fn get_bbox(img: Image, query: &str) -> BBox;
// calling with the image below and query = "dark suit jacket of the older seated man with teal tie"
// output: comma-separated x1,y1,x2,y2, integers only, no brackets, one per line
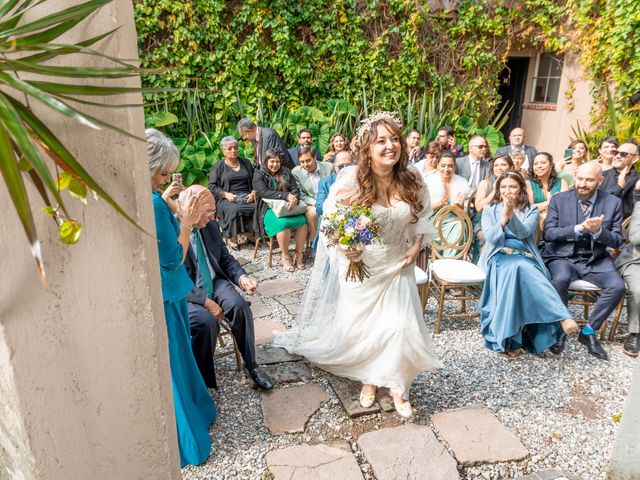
184,220,247,305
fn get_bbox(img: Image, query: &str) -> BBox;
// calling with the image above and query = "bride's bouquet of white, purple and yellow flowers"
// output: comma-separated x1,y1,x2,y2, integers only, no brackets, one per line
321,203,382,282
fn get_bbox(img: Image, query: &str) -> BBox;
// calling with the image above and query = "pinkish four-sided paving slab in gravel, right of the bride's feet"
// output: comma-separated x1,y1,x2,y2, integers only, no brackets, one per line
431,407,529,466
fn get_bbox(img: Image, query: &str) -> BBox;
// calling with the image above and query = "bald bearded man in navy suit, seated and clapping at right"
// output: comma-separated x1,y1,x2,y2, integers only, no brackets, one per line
542,161,625,360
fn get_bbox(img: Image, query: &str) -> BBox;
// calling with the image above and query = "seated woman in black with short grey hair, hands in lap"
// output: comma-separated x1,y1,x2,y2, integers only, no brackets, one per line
209,136,256,249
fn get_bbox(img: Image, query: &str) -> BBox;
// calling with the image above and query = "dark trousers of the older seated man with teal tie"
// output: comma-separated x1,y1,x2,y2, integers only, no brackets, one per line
189,278,257,388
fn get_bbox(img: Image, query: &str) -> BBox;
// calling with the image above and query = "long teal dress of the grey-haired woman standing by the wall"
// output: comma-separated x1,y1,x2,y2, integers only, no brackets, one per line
153,192,217,467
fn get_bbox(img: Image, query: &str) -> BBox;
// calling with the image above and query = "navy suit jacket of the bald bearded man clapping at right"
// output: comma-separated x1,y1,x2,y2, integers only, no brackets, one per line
542,190,624,272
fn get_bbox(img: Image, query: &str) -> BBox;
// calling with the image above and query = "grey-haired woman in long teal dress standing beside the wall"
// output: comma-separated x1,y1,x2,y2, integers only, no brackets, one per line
146,129,216,467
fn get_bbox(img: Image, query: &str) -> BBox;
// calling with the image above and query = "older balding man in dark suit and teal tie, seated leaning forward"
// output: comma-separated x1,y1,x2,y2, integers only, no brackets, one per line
179,185,273,390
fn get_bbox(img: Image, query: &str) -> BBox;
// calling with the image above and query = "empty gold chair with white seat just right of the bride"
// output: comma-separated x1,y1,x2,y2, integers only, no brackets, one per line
427,205,485,333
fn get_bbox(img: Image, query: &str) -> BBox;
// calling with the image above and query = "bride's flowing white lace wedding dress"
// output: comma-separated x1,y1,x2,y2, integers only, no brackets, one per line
274,167,442,398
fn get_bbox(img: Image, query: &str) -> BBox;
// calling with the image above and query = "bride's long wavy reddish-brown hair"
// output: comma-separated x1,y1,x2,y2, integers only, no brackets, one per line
355,118,424,222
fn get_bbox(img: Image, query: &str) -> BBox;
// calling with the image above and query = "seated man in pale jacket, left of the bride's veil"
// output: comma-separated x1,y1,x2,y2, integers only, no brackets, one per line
291,147,335,241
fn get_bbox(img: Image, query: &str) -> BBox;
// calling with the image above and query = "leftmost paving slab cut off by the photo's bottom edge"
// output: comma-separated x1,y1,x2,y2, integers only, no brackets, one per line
267,445,362,480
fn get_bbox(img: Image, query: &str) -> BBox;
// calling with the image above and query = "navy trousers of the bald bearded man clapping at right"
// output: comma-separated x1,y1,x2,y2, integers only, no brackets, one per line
547,258,626,330
